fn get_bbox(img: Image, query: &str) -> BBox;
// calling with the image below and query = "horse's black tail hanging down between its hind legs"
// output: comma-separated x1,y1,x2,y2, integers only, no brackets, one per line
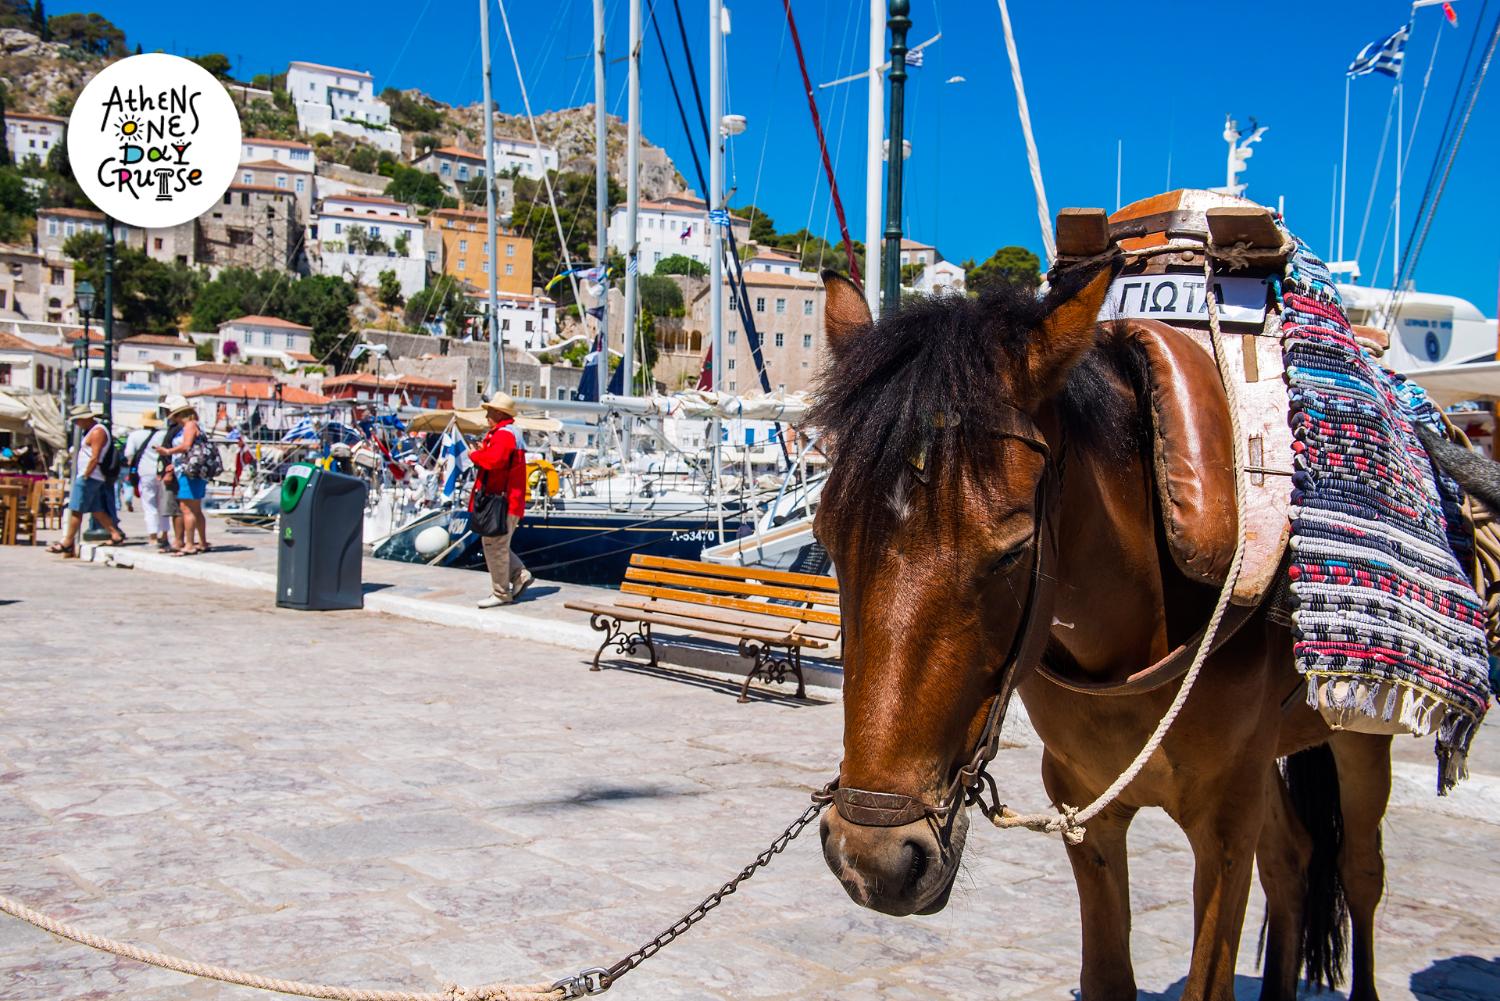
1284,744,1349,989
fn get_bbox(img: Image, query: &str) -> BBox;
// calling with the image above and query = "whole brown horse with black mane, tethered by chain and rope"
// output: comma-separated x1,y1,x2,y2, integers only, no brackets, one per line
813,262,1391,1001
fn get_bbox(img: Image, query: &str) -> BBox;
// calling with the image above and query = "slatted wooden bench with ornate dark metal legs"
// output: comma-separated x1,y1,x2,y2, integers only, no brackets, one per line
566,554,842,702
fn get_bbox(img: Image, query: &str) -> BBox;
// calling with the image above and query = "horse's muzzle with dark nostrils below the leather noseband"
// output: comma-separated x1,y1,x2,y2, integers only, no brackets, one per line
821,804,969,917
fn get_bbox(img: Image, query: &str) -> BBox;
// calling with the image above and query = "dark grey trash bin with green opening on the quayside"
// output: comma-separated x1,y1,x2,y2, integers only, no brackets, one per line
276,464,369,611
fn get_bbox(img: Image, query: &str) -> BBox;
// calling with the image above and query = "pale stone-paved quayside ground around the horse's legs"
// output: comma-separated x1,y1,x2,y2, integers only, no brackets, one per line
0,549,1500,1001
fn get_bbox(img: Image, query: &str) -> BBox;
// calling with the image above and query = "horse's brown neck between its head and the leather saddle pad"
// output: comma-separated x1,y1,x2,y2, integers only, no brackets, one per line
1052,435,1169,678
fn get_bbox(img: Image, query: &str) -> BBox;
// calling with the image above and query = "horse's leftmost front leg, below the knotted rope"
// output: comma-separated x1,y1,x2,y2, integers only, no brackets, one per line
1041,755,1136,1001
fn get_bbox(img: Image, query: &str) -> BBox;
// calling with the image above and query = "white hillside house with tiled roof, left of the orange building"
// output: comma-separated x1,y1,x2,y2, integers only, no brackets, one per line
314,195,428,297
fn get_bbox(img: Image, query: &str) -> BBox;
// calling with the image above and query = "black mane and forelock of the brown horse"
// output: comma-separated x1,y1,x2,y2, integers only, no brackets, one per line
810,274,1140,525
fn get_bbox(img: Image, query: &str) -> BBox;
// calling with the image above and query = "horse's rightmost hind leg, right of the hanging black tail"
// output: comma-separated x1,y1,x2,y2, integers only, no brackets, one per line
1328,731,1391,1001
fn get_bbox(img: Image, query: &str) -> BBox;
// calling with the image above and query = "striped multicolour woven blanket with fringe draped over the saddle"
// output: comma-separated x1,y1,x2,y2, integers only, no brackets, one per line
1278,242,1490,794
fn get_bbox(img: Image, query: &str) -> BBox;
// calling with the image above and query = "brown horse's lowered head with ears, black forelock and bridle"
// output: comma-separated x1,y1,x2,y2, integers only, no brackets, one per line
813,270,1110,914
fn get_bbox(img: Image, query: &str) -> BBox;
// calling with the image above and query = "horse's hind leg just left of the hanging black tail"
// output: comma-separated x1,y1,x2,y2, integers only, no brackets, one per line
1256,768,1313,1001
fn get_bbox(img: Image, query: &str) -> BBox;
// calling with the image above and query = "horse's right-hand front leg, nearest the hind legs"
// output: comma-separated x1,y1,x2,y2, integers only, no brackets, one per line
1175,768,1272,1001
